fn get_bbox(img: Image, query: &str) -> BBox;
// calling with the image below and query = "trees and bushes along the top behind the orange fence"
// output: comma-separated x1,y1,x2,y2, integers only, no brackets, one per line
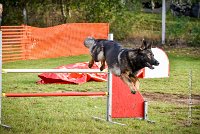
3,0,141,39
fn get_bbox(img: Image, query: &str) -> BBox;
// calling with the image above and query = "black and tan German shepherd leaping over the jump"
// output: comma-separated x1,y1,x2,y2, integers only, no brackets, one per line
84,37,159,94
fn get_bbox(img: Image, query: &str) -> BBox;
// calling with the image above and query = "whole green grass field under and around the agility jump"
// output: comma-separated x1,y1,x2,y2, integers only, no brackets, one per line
0,47,200,134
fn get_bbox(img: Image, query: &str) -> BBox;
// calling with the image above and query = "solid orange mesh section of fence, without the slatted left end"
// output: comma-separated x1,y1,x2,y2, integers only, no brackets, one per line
27,23,109,59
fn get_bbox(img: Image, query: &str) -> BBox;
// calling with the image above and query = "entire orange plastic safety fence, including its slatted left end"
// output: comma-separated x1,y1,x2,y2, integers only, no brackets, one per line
2,23,109,61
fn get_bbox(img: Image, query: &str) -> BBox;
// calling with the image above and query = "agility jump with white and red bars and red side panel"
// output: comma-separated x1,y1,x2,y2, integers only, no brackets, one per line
0,31,147,127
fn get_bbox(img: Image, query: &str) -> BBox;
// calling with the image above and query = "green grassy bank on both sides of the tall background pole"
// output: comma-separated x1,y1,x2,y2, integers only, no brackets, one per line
131,13,200,47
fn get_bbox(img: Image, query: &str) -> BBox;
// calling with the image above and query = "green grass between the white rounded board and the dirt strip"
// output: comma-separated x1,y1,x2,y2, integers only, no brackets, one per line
141,54,200,95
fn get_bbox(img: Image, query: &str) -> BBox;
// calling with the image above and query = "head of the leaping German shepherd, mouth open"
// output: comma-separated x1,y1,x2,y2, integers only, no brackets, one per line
129,39,159,69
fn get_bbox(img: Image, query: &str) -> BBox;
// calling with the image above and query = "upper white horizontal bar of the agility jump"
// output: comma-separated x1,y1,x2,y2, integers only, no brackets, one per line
2,69,107,73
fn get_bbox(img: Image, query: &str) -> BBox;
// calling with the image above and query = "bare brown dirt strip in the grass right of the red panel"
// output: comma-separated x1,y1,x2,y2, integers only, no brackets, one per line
142,92,200,105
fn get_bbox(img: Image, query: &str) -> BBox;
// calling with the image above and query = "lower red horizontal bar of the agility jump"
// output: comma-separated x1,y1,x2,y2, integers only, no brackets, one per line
2,92,108,97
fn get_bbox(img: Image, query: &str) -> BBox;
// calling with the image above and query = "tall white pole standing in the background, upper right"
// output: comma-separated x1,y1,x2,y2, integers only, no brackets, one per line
162,0,166,45
